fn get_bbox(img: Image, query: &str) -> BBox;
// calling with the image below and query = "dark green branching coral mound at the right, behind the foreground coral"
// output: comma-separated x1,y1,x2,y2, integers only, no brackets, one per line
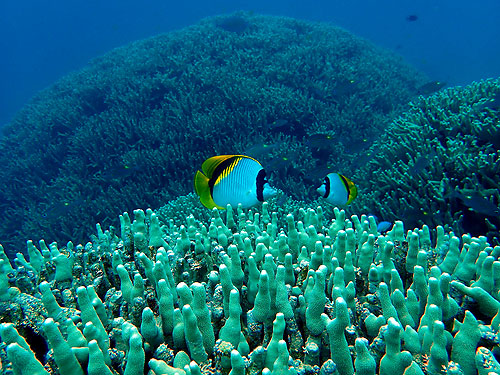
353,78,500,244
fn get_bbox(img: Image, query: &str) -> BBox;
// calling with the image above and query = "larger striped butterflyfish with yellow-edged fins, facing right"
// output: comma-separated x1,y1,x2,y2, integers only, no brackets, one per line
194,155,276,209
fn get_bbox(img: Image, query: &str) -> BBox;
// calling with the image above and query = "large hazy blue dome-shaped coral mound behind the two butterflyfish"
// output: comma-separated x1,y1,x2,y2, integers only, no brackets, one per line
0,14,425,252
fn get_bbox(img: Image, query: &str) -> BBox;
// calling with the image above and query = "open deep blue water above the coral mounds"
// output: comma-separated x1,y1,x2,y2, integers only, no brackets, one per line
0,0,500,125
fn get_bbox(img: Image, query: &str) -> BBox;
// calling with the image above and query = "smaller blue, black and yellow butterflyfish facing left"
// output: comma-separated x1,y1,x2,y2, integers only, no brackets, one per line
316,173,358,206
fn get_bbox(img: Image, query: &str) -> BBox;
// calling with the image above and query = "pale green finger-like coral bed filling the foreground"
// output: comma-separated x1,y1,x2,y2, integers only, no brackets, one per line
0,197,500,375
